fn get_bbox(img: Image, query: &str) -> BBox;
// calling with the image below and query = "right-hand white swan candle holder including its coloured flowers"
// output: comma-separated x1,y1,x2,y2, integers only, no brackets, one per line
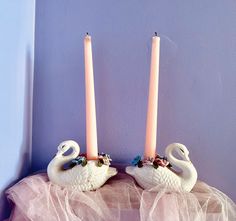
126,143,197,192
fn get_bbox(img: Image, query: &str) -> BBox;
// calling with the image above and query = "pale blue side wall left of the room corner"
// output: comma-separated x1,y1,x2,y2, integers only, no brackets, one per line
0,0,35,220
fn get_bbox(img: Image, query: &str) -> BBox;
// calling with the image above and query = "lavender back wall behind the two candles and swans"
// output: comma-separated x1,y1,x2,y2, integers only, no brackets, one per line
33,0,236,200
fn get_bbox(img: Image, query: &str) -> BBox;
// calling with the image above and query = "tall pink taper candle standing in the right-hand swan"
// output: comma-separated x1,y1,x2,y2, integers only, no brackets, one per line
144,36,160,158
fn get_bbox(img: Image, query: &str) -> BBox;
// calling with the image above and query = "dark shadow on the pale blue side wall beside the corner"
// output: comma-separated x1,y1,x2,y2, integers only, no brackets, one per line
0,48,33,220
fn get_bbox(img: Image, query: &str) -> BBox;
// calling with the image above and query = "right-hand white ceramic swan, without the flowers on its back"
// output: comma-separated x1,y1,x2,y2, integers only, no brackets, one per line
126,143,197,192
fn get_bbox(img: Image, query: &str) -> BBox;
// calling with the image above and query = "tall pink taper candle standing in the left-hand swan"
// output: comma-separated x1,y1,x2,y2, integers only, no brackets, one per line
84,34,98,160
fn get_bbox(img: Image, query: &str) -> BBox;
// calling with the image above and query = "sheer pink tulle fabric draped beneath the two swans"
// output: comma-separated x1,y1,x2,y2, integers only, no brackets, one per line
7,173,236,221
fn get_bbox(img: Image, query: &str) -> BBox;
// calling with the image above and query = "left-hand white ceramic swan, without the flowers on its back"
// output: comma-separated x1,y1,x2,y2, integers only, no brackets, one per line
47,140,117,191
